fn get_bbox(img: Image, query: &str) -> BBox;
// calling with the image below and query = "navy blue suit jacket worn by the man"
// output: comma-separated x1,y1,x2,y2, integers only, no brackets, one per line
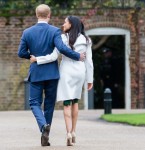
18,23,80,82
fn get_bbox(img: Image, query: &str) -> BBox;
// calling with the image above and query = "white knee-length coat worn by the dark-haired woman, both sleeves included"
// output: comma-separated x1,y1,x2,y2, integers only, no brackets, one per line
36,34,94,101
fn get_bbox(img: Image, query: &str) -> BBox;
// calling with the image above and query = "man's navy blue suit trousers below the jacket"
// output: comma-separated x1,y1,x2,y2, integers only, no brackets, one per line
29,79,58,131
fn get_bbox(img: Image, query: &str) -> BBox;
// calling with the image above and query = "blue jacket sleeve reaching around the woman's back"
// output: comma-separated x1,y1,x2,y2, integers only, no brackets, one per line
54,29,80,60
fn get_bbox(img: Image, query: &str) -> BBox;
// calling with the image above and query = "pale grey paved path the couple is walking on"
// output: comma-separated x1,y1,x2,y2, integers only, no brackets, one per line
0,110,145,150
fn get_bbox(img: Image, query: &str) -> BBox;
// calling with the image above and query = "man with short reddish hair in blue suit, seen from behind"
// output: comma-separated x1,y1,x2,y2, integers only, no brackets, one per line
18,4,85,146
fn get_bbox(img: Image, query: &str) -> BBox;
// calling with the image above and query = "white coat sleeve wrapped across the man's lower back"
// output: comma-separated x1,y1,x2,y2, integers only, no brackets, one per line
36,48,59,65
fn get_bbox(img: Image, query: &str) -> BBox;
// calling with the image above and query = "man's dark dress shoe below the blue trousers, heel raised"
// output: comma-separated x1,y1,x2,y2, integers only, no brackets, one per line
41,124,50,146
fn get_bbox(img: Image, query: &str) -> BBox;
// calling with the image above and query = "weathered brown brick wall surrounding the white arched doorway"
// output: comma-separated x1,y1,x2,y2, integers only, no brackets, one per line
0,9,145,110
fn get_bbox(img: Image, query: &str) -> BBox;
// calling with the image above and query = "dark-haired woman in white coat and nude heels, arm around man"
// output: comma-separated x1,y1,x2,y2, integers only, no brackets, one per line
31,16,93,146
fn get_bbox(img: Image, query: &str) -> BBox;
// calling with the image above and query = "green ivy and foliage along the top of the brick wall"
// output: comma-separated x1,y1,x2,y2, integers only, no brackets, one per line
0,0,145,16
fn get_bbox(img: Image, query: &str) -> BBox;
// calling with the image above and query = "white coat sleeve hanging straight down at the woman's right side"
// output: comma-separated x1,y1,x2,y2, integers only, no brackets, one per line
85,39,94,83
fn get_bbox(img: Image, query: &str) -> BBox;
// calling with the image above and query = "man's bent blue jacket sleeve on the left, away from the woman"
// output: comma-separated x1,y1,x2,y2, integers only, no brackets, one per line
18,32,30,59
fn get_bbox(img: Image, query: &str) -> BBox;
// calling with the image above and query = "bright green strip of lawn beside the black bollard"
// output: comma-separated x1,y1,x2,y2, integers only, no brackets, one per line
101,113,145,126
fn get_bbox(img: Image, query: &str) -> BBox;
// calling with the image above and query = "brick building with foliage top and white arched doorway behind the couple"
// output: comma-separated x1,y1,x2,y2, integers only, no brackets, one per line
0,0,145,110
